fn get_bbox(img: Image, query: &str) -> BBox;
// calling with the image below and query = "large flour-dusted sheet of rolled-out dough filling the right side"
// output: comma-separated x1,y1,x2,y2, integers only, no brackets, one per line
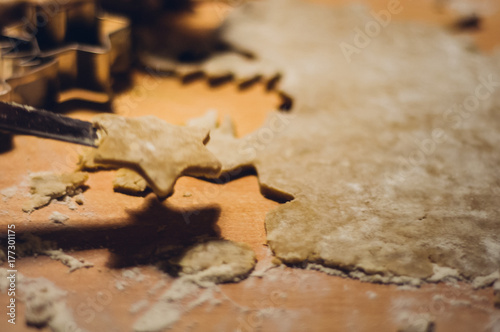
182,0,500,280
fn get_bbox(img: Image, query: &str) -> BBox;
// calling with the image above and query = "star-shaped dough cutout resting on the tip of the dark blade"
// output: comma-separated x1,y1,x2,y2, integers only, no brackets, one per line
93,114,221,198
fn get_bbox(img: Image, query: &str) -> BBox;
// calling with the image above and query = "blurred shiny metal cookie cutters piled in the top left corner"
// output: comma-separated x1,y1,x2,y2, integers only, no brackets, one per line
0,0,131,107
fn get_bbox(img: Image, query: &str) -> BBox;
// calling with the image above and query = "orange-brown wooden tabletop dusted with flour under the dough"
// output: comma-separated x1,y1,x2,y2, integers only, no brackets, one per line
0,0,500,331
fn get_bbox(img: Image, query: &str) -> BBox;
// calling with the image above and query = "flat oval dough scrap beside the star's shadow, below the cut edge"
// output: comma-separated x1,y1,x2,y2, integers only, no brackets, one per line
177,240,257,283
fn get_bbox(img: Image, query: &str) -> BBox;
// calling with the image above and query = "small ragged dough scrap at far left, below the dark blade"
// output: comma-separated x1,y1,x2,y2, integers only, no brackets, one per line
23,172,88,213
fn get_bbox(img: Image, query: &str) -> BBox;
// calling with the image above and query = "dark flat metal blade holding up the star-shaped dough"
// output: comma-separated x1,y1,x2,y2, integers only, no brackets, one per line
0,102,98,147
